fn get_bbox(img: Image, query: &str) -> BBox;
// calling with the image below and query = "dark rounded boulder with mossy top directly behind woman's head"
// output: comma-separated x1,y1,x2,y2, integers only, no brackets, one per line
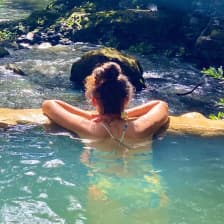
70,48,145,91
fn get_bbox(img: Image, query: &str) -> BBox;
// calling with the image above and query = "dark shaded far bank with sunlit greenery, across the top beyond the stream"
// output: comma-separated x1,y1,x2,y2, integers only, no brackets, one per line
0,0,224,63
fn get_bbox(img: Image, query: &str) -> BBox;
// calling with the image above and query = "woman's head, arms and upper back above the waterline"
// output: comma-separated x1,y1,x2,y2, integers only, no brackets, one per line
42,62,168,144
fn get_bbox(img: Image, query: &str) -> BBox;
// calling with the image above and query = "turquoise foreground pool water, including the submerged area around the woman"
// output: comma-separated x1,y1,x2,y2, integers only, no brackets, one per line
0,126,224,224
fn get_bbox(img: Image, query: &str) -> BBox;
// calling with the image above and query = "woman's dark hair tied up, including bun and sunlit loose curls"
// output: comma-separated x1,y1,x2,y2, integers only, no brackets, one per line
85,62,134,115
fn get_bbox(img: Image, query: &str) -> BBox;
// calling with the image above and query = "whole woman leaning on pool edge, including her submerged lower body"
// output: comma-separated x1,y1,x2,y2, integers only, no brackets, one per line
42,62,168,224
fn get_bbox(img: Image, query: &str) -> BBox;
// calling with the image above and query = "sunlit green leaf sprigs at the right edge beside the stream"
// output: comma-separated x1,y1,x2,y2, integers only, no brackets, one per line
202,66,224,120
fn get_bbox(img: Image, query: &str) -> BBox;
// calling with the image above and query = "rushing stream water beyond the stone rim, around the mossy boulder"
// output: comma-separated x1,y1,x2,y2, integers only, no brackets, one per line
0,0,224,116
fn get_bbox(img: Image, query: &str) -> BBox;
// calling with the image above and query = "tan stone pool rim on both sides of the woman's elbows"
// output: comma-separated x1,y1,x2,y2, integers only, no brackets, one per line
0,108,224,137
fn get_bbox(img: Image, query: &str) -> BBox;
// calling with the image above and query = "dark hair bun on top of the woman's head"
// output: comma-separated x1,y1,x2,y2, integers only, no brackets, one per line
95,62,122,85
